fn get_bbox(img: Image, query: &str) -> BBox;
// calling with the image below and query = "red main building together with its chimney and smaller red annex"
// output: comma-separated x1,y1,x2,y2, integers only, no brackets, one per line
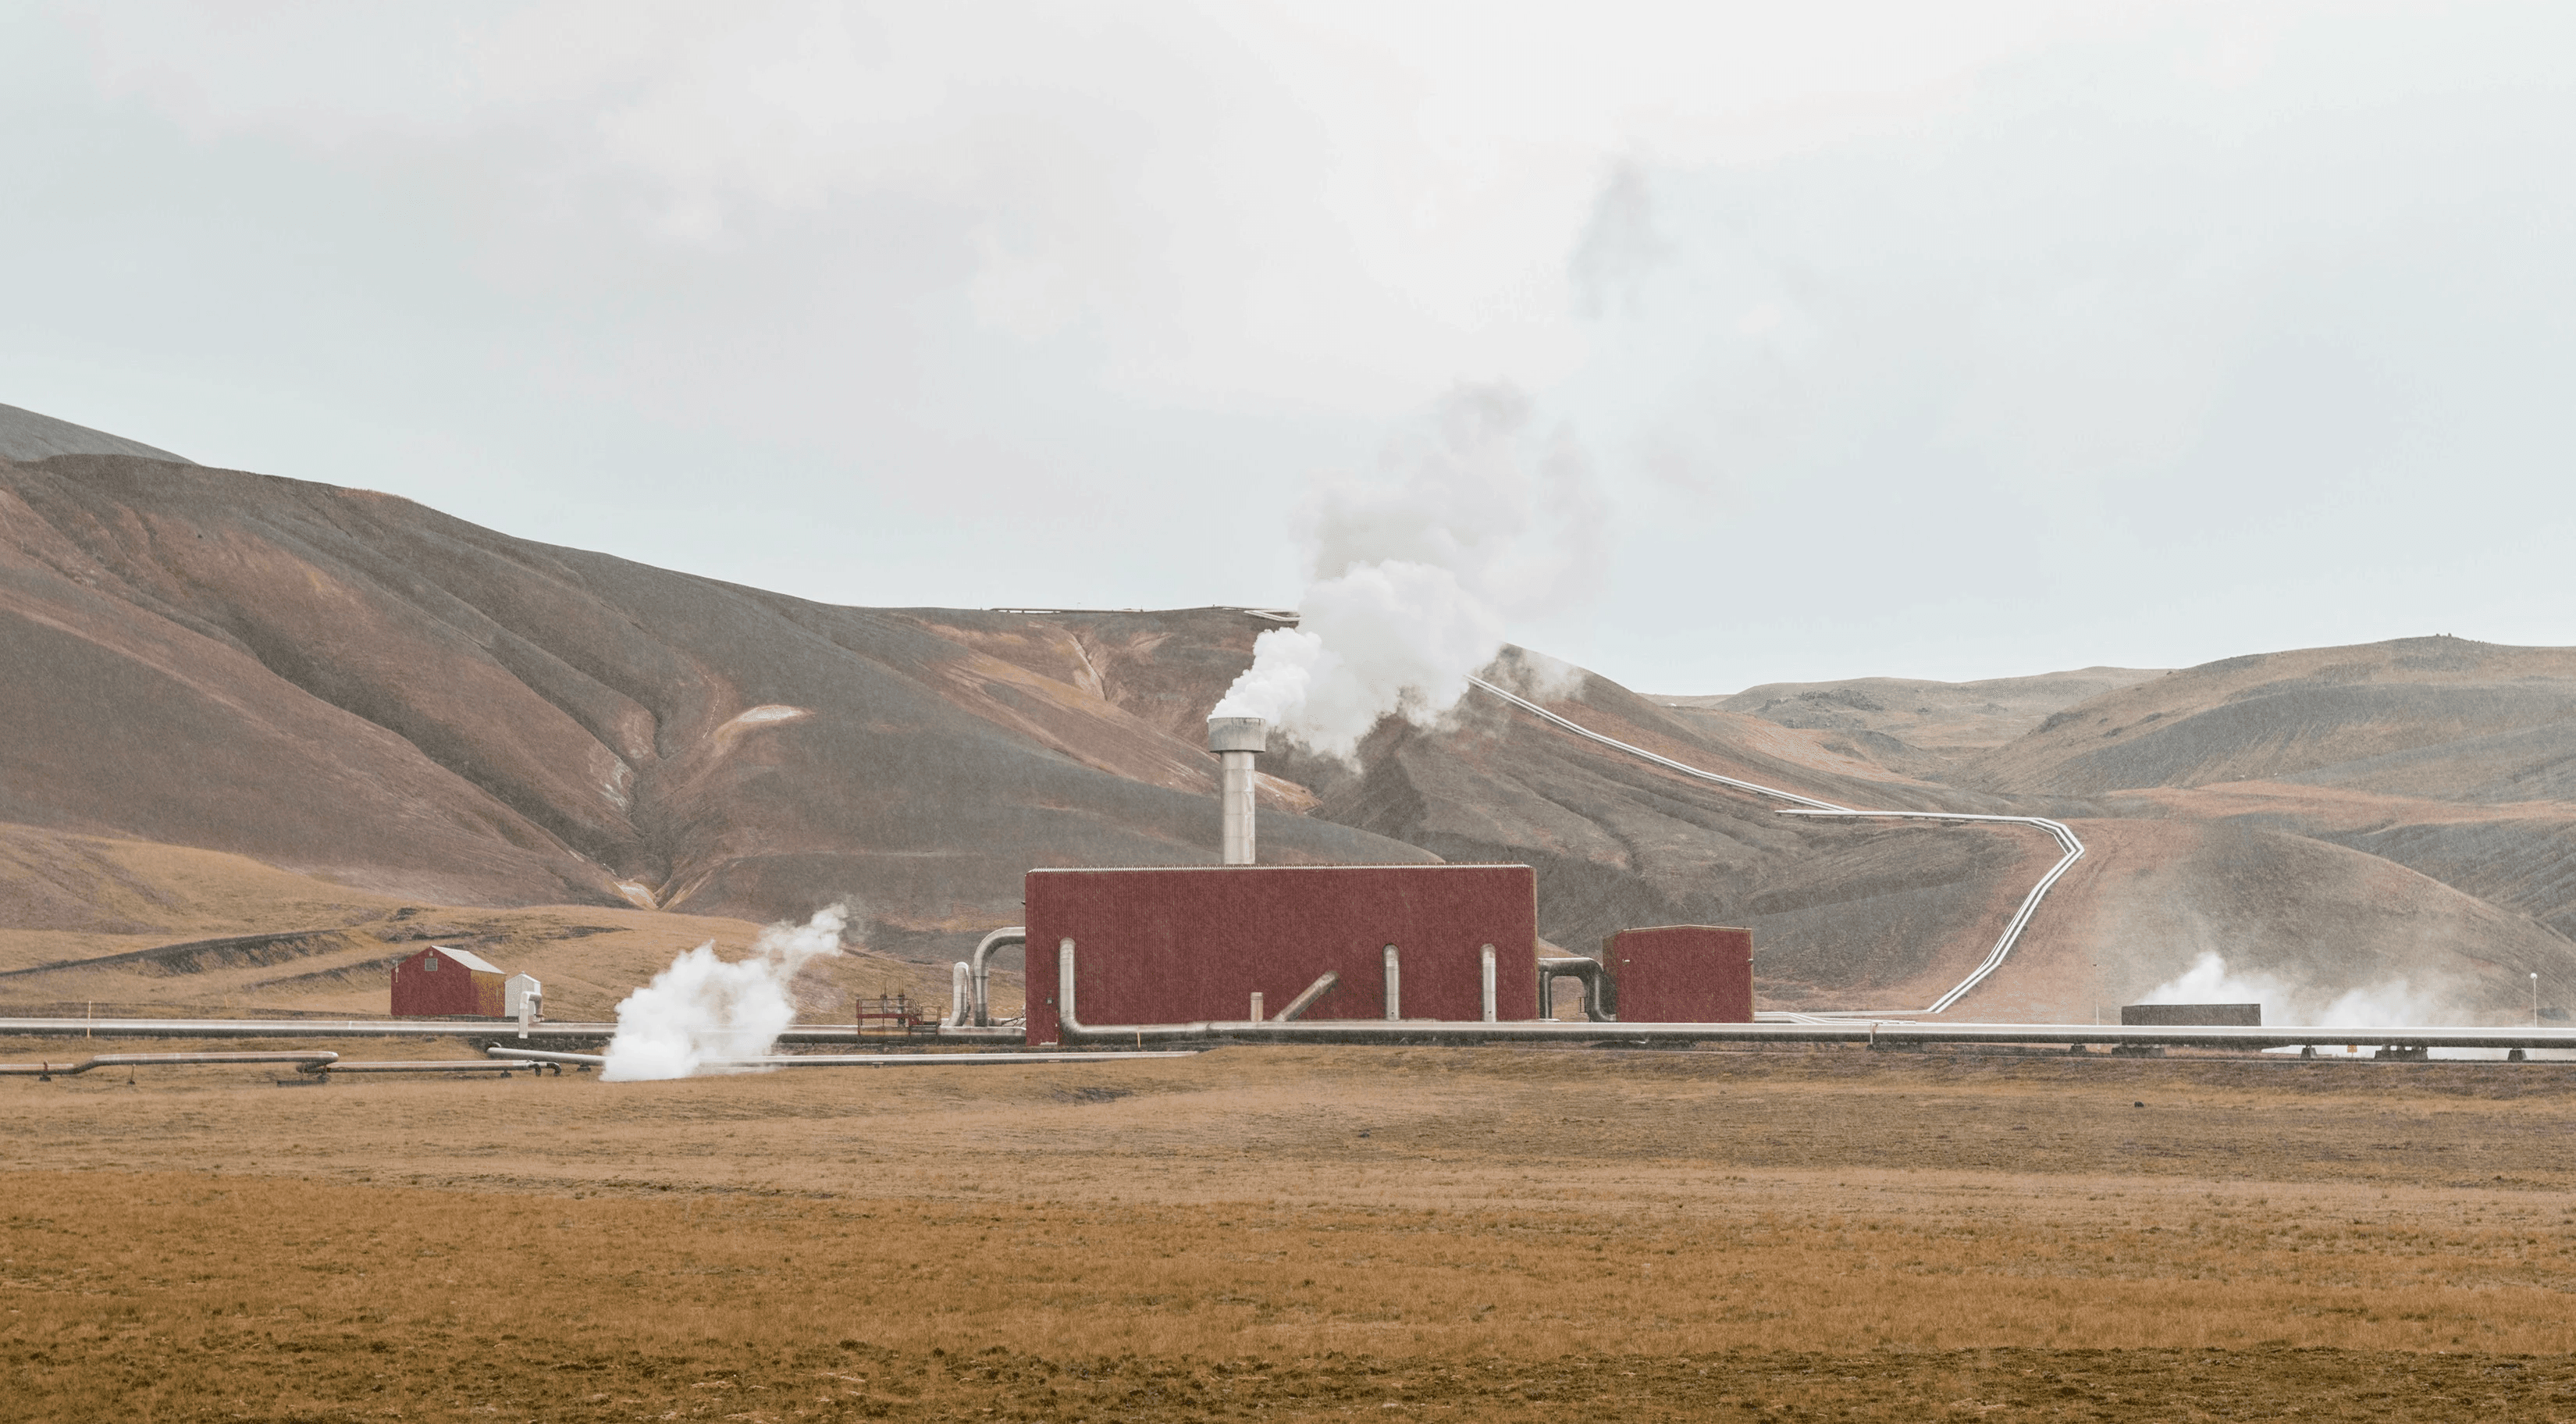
955,716,1754,1048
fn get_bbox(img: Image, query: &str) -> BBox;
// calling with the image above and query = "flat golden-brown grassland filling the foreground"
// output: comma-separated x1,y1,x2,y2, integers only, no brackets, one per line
0,1043,2576,1422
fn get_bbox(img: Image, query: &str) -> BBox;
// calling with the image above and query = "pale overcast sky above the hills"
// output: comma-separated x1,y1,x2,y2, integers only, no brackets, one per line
0,0,2576,692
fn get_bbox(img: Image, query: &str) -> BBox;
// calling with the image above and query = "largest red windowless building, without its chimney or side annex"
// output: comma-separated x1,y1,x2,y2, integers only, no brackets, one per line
1028,865,1538,1043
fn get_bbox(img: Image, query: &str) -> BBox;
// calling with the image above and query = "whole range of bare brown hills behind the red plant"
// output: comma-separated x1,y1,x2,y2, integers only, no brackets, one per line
0,422,2576,1017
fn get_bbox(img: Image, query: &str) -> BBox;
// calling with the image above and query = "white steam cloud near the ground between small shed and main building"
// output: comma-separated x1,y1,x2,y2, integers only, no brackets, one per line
600,904,850,1081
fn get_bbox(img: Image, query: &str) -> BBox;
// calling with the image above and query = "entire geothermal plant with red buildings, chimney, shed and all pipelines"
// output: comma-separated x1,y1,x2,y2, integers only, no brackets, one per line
15,680,2576,1081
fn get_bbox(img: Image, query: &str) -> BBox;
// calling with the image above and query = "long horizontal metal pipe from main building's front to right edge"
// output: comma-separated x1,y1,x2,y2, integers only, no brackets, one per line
1056,940,2576,1048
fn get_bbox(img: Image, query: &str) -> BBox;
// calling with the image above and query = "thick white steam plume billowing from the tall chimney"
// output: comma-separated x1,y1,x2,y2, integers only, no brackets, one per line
1211,386,1605,757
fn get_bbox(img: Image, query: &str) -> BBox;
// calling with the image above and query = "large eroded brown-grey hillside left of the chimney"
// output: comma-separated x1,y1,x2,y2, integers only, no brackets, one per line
0,456,1422,938
